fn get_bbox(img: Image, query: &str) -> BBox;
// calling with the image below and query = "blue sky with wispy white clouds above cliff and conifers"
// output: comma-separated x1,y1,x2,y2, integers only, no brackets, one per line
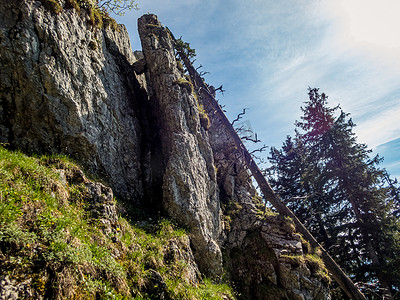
114,0,400,179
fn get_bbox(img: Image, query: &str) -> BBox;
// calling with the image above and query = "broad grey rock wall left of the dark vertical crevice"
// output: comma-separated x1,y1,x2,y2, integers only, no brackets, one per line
0,0,143,199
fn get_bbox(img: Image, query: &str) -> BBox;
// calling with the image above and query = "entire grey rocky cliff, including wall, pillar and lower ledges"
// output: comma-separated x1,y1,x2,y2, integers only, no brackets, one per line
0,0,329,299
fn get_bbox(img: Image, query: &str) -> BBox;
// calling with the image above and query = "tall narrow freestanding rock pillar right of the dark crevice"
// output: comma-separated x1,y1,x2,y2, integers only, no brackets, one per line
138,15,222,276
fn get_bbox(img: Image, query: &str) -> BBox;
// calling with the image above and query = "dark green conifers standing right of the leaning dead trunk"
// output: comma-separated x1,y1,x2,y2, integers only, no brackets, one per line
269,89,400,294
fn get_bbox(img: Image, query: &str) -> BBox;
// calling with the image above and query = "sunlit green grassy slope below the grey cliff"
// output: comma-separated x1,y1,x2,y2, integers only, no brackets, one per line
0,147,234,299
